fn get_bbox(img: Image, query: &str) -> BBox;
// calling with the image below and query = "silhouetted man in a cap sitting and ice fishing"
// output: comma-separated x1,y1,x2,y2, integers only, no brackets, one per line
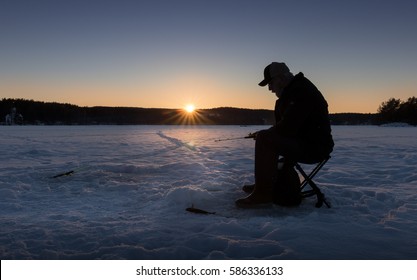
236,62,334,208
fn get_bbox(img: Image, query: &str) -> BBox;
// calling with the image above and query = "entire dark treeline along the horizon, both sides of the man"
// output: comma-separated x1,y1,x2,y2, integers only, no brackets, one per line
0,97,417,125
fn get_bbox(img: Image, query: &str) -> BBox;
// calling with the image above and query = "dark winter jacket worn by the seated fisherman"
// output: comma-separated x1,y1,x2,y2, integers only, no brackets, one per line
275,72,334,161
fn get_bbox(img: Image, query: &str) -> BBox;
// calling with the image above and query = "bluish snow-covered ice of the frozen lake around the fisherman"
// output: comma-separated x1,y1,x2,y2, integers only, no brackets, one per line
0,126,417,259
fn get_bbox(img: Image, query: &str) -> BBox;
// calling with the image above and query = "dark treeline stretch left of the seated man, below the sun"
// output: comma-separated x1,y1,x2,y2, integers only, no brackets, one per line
0,98,274,125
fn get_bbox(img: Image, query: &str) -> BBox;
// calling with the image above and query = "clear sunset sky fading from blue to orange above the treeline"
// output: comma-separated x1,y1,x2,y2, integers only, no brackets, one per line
0,0,417,113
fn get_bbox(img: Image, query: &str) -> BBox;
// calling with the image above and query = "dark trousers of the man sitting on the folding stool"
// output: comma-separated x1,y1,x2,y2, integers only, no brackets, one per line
255,127,303,191
